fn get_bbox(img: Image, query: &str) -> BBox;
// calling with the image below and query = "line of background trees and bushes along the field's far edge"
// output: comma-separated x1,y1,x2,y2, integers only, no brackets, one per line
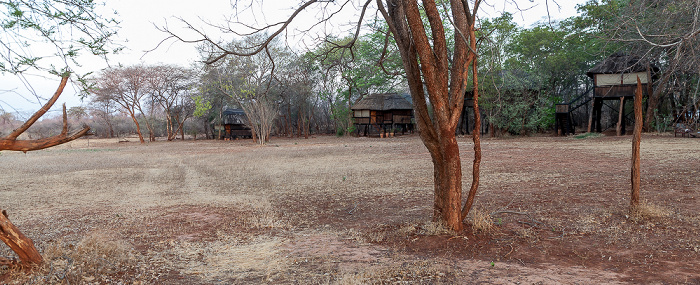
8,0,680,142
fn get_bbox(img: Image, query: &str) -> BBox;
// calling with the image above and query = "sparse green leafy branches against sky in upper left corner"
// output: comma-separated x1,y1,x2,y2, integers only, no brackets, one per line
0,0,122,75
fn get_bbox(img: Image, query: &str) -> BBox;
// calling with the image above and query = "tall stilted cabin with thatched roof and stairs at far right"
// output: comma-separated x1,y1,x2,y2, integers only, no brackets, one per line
555,52,659,135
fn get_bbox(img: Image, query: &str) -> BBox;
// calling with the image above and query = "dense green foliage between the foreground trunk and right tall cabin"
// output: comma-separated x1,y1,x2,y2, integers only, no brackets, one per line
479,7,617,134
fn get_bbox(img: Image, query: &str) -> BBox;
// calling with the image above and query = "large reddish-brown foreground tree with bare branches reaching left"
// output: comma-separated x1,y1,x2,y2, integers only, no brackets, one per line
162,0,481,231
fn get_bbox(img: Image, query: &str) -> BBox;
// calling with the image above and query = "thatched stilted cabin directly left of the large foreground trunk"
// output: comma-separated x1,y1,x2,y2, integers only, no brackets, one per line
350,93,413,136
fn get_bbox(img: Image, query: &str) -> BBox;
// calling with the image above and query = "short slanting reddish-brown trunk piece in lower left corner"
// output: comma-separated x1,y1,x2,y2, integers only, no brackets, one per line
0,210,44,266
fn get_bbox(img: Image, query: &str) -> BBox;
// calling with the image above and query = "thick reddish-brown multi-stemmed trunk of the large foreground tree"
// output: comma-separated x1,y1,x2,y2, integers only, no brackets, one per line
377,0,480,231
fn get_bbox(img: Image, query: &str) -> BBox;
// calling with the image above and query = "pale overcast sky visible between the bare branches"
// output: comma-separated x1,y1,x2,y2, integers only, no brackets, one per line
0,0,585,117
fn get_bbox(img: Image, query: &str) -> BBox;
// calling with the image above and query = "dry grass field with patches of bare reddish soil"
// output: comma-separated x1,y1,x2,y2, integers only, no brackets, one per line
0,135,700,284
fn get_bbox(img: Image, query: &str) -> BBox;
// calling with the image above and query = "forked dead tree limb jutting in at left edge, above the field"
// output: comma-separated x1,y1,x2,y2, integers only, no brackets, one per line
0,76,90,152
